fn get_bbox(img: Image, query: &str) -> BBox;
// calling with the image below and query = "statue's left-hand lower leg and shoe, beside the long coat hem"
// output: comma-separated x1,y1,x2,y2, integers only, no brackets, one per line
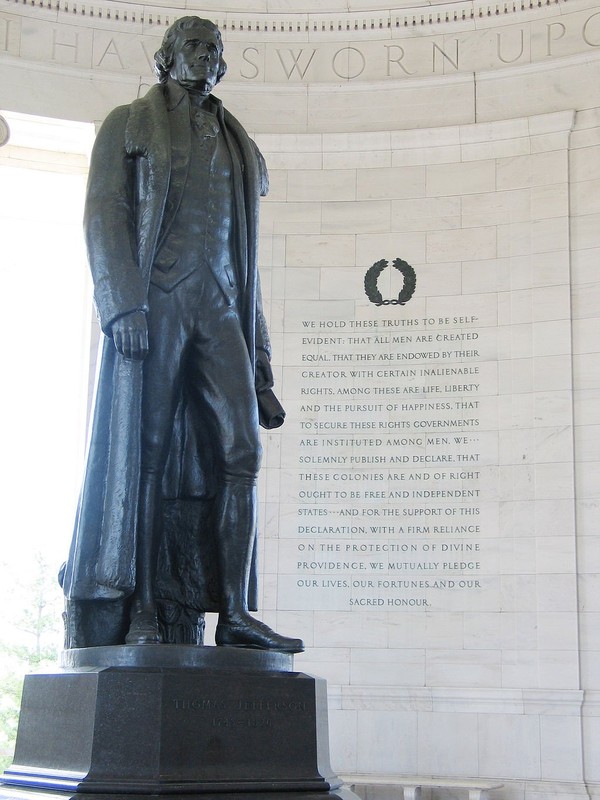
125,474,162,644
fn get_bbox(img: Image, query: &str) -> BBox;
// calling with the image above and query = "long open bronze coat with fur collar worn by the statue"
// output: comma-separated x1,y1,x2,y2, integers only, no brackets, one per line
63,81,269,610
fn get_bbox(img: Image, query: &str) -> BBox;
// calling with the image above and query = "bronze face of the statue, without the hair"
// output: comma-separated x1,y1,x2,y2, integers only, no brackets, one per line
169,27,221,94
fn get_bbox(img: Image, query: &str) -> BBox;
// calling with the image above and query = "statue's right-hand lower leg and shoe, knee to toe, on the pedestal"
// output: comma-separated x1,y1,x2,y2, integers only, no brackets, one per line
215,483,304,653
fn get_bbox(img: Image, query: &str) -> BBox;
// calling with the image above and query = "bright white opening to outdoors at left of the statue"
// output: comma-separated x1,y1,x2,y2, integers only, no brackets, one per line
0,111,94,766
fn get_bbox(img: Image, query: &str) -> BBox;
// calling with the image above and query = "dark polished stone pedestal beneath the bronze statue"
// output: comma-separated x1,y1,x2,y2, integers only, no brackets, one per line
0,645,346,800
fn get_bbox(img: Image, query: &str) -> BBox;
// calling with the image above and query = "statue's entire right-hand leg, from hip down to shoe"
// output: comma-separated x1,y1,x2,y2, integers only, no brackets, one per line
190,303,304,653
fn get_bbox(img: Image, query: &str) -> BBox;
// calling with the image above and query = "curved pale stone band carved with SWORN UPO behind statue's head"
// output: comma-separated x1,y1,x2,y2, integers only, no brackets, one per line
0,7,600,84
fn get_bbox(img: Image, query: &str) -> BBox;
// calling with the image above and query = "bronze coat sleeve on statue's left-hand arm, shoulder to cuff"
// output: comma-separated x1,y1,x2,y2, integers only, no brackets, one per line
84,106,147,336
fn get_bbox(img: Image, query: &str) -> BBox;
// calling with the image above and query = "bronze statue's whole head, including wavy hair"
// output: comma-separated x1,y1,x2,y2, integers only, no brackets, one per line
154,17,227,94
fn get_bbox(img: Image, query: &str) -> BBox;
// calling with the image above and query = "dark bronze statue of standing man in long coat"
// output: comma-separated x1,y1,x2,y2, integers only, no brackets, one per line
63,17,303,652
